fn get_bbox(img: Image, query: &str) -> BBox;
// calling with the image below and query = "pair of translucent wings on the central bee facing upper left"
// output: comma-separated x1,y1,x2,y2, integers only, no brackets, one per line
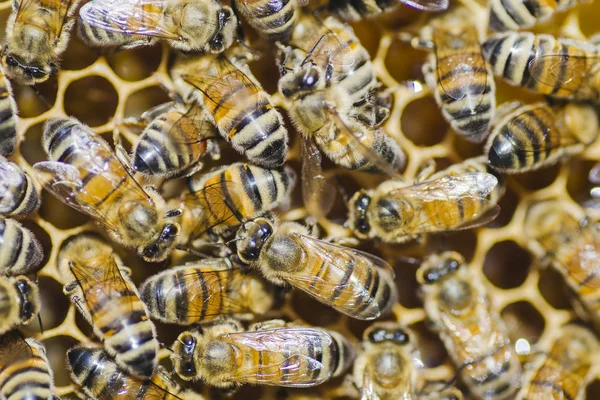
286,235,395,319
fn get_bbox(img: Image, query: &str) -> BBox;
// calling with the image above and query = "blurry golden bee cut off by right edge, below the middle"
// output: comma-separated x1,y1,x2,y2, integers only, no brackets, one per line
525,200,600,328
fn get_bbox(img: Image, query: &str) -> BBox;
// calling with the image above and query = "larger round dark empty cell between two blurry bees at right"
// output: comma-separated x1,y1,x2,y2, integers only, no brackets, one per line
483,240,531,289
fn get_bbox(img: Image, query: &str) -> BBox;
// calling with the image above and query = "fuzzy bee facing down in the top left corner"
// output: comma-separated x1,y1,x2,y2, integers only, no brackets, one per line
1,0,79,85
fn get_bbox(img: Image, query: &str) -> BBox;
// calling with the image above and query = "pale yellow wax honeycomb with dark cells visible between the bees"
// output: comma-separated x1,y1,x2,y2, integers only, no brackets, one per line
0,0,600,399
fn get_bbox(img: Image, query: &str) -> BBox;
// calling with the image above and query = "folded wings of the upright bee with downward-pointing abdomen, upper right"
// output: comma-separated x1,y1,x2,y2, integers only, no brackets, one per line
434,28,489,100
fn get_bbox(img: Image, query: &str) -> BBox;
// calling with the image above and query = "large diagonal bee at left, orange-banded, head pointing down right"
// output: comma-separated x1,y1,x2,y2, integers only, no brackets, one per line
34,118,179,262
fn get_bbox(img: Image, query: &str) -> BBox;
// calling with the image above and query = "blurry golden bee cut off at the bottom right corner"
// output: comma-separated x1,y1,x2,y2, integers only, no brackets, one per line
517,325,599,400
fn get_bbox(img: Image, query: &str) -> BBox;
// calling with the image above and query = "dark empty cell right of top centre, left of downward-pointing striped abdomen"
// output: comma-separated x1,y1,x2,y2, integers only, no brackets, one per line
400,96,448,146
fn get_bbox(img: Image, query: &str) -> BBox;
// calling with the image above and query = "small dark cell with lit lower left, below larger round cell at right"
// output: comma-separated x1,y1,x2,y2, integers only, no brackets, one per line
501,301,546,344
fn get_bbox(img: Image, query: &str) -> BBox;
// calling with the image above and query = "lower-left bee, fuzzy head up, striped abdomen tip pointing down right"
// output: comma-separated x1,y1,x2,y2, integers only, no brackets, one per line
57,234,159,379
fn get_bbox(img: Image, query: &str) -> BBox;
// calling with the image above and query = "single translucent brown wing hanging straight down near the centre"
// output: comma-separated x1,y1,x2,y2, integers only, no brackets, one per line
302,138,335,218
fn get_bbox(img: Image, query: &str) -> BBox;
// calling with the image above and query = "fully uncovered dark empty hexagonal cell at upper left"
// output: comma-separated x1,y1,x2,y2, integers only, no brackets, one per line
64,76,119,127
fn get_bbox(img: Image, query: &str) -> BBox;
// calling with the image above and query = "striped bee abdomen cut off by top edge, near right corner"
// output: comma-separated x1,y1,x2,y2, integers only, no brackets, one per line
489,0,589,31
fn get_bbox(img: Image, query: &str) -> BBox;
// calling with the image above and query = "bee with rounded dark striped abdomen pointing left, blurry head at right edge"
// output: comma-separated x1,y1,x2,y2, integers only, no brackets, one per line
485,103,600,173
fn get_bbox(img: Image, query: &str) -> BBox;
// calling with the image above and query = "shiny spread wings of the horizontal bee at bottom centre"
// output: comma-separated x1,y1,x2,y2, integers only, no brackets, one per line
225,327,332,387
